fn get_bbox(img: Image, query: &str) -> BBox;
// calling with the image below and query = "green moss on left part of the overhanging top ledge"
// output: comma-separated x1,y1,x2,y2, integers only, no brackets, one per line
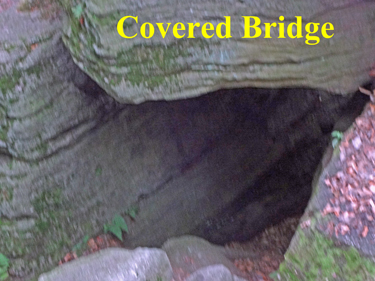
63,5,212,90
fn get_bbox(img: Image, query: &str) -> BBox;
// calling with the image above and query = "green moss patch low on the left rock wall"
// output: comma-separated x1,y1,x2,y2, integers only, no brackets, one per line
0,184,98,278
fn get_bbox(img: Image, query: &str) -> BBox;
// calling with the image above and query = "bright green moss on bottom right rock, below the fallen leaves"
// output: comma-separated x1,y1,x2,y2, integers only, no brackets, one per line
278,230,375,281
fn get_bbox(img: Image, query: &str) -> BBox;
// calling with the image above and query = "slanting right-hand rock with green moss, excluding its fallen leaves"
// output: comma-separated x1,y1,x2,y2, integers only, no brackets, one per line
280,106,375,281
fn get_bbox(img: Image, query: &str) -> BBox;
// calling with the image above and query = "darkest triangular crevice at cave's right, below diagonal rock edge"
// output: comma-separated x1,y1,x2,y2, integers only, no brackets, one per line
194,90,368,244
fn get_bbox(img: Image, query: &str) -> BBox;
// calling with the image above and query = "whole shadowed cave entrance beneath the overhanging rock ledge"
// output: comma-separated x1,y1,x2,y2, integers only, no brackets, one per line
67,78,368,270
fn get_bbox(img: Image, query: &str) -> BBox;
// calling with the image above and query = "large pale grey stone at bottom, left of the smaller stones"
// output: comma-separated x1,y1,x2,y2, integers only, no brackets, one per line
38,248,172,281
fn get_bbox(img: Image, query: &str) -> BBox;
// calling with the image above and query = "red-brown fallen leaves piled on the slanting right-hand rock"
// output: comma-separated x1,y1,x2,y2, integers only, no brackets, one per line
322,101,375,237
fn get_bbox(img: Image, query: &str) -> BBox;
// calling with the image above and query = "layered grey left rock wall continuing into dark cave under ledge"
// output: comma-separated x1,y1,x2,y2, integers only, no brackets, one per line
0,1,372,281
